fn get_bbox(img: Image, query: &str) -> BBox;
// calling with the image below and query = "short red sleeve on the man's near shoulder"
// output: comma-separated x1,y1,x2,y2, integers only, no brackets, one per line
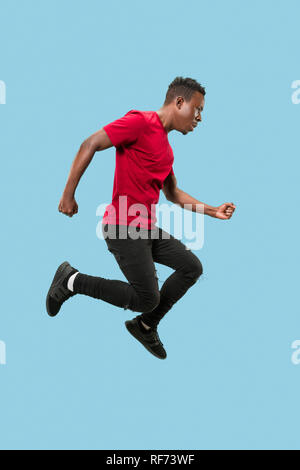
103,109,146,147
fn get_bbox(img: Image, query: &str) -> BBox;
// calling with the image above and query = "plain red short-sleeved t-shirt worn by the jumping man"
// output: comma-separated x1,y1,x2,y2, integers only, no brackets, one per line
102,109,174,229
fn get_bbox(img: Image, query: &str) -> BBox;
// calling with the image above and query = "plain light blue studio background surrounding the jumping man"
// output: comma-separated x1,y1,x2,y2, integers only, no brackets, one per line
0,0,300,449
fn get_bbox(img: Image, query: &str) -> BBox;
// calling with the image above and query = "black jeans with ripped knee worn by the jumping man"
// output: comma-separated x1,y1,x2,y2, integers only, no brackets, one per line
74,224,203,327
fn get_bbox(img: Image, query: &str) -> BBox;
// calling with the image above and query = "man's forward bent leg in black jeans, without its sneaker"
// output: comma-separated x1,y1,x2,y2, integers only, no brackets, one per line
140,228,203,327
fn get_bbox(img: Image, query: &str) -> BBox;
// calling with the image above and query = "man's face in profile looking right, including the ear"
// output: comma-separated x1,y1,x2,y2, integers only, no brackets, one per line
175,91,205,135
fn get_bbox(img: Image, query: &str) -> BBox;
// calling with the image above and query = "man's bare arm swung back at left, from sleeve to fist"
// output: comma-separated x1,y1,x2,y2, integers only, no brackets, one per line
58,129,113,217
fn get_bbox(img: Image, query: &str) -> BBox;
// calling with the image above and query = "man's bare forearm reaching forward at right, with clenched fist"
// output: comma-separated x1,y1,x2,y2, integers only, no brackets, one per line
162,175,236,220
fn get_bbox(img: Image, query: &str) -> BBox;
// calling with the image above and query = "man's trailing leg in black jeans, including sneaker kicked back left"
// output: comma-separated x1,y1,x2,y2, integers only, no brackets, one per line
47,225,160,316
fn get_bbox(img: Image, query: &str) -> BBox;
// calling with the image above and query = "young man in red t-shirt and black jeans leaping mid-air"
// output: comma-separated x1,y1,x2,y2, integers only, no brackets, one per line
46,77,235,359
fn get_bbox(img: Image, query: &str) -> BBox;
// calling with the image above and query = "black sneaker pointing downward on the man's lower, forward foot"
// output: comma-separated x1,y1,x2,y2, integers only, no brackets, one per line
125,317,167,359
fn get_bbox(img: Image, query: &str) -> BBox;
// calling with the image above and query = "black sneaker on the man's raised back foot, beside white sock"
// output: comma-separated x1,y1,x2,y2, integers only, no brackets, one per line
46,261,77,317
